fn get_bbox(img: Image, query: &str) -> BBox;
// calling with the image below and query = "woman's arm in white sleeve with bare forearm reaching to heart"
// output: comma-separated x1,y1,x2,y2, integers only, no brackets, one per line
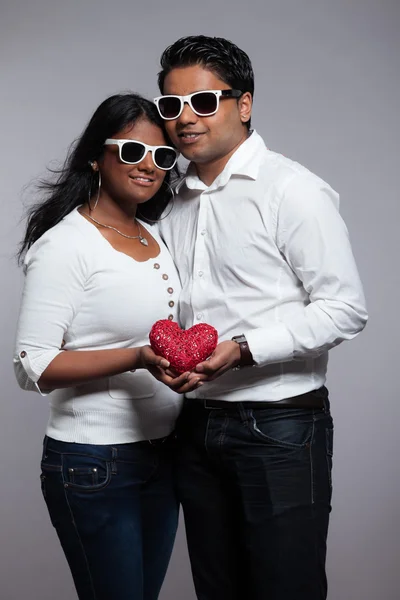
14,226,168,393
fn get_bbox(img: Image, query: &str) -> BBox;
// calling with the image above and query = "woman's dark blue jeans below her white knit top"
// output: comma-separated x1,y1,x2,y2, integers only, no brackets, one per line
41,437,178,600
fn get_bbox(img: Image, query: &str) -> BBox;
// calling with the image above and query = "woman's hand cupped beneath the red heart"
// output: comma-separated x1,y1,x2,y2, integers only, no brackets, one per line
140,346,204,394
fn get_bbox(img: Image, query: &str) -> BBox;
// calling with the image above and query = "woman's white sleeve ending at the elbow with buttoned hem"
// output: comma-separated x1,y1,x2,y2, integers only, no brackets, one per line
13,230,86,395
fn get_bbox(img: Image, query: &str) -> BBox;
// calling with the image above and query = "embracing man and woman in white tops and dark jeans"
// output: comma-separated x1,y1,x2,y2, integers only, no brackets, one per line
14,36,367,600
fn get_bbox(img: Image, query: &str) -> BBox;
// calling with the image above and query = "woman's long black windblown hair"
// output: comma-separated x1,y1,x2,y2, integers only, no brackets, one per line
18,93,178,261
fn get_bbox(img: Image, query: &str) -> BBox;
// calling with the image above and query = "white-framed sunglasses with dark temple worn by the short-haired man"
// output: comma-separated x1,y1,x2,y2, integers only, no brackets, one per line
154,90,243,121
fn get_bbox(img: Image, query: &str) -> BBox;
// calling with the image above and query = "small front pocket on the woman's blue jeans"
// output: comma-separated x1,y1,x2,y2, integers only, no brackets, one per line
63,454,112,492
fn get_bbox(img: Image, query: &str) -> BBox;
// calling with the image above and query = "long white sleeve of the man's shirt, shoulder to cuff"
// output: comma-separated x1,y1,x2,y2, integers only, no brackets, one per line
245,175,368,366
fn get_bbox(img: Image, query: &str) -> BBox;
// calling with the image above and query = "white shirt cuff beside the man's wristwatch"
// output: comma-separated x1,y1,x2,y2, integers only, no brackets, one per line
244,323,294,367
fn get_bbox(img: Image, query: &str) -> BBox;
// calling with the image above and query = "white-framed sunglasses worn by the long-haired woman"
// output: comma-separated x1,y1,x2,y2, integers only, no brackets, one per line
104,138,179,171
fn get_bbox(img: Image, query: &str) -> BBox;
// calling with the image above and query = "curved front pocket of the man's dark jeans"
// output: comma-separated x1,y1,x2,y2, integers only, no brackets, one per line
248,408,313,450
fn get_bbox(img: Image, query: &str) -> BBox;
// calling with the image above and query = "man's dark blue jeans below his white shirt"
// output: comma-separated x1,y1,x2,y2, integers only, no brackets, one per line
177,388,333,600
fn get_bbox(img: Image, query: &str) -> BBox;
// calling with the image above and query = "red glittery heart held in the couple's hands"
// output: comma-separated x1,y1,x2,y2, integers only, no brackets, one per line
149,319,218,373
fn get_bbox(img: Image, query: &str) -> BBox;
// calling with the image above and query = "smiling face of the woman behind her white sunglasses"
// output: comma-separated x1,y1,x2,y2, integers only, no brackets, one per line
98,119,166,206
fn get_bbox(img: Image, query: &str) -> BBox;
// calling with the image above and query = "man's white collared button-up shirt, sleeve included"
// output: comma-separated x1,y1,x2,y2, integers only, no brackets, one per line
160,131,367,401
